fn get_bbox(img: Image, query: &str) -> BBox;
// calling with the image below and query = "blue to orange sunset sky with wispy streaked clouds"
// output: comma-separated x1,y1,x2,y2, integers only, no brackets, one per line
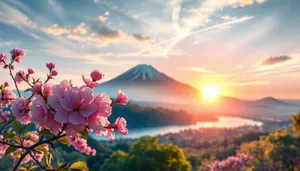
0,0,300,99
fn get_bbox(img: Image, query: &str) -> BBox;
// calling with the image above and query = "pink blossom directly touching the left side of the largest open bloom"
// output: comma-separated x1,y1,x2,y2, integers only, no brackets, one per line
30,95,63,135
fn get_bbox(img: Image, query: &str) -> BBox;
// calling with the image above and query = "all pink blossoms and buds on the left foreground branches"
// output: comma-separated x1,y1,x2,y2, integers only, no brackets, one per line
0,48,128,160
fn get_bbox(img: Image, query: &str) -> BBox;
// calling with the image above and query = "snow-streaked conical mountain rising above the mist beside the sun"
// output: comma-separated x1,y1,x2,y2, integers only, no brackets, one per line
94,64,200,103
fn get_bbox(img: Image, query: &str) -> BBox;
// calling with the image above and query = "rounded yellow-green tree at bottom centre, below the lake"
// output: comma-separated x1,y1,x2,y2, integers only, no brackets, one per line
100,137,192,171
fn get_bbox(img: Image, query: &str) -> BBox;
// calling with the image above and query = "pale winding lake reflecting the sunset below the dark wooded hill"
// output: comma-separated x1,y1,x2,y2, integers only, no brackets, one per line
94,116,263,140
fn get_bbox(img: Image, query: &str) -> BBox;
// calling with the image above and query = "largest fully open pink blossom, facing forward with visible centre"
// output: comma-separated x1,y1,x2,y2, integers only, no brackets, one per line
48,81,97,125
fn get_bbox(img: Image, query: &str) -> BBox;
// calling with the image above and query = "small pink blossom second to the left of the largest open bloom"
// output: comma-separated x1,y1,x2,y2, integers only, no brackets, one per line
11,97,31,125
